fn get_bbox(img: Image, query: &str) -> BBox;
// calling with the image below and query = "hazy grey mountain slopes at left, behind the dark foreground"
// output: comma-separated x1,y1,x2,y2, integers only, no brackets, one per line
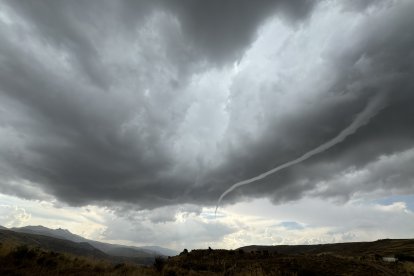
0,226,177,264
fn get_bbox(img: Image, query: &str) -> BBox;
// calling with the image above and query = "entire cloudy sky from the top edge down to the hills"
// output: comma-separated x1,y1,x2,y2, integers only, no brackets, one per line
0,0,414,251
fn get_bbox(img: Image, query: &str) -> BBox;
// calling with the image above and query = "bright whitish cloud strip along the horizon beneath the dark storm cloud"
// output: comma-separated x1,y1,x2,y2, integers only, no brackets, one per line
0,195,414,252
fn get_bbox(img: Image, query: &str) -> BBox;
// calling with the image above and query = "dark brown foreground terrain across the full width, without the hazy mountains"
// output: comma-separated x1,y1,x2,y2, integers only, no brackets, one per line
0,236,414,276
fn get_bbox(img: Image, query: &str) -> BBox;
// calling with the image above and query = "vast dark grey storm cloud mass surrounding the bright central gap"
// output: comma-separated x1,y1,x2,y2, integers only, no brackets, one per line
0,0,414,208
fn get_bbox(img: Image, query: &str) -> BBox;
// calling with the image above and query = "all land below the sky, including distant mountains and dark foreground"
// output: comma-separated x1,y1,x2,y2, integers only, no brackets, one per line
0,226,414,276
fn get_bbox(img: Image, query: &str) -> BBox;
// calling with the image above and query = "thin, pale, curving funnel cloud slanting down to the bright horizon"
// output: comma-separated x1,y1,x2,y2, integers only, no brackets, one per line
214,93,385,217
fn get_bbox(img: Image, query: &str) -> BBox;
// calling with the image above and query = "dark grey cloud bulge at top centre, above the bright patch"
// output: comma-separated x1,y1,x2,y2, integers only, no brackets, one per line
165,0,316,64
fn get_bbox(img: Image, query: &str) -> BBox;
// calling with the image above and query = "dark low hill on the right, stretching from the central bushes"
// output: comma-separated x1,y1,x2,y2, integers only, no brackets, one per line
162,240,414,276
